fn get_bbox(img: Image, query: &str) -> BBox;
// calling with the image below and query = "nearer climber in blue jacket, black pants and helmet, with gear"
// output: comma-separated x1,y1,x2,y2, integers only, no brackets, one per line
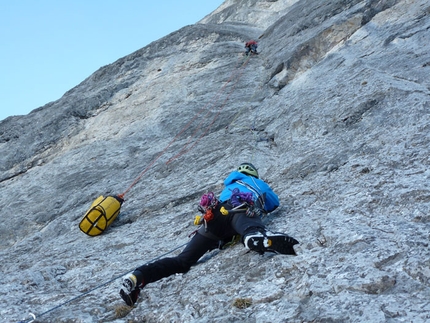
120,163,299,306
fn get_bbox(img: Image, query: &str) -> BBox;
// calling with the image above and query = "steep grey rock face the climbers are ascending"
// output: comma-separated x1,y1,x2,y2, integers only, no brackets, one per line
0,0,430,323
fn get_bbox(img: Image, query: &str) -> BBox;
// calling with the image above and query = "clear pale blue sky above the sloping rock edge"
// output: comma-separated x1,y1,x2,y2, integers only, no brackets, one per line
0,0,223,120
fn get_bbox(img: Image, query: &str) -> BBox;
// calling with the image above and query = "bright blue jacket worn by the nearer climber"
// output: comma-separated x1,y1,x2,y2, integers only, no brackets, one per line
219,171,279,212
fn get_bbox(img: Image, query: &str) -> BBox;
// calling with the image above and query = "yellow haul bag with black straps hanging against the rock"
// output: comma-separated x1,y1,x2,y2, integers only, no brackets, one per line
79,196,124,237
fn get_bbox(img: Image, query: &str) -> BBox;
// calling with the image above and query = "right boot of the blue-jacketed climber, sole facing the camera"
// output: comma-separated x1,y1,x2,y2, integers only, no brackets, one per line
243,231,299,255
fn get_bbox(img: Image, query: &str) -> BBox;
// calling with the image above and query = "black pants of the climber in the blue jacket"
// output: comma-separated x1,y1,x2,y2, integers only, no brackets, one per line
133,204,264,286
